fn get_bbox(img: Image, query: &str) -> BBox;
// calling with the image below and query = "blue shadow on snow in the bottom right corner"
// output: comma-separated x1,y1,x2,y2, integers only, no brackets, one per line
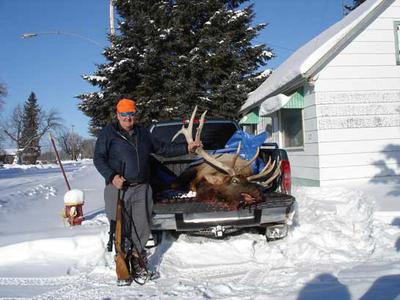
360,275,400,300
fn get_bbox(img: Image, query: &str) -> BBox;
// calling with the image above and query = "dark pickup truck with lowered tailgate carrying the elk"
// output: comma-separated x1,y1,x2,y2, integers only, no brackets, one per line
150,120,296,241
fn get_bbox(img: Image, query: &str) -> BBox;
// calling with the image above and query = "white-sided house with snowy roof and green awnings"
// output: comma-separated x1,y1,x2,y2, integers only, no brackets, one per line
241,0,400,186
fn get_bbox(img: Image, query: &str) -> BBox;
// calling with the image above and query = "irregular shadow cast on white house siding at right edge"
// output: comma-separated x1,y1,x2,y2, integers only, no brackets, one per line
370,144,400,196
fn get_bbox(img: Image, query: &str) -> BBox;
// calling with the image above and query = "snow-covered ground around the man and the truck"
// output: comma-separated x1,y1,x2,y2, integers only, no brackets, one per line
0,161,400,300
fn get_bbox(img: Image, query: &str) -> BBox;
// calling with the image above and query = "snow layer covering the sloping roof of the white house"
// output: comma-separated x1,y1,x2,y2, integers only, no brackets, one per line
240,0,394,112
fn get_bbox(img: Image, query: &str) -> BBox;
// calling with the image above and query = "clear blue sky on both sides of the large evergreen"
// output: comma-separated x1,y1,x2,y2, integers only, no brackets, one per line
0,0,351,137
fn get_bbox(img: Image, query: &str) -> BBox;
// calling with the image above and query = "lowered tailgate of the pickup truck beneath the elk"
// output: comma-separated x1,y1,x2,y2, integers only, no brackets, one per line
152,192,295,231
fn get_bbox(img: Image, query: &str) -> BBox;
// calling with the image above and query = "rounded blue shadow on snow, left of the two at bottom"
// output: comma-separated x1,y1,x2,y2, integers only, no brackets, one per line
297,273,351,300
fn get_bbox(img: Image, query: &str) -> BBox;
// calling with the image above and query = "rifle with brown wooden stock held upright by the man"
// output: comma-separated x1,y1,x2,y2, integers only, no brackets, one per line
115,163,131,283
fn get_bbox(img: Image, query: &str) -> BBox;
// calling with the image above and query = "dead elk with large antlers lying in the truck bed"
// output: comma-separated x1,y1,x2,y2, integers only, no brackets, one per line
172,106,280,210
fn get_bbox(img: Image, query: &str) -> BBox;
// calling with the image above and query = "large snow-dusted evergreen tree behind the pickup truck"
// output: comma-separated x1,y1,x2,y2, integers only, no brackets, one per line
78,0,272,129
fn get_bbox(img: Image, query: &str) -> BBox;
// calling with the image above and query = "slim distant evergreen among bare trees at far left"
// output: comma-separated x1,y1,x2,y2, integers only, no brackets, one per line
18,92,40,161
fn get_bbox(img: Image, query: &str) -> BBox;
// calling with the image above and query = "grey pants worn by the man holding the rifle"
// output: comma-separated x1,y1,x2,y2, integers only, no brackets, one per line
104,184,153,252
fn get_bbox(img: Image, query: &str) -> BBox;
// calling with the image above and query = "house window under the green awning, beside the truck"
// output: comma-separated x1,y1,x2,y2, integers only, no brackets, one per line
281,109,304,148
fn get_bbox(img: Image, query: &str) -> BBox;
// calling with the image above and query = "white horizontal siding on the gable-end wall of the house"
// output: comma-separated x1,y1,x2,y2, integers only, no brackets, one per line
312,0,400,185
